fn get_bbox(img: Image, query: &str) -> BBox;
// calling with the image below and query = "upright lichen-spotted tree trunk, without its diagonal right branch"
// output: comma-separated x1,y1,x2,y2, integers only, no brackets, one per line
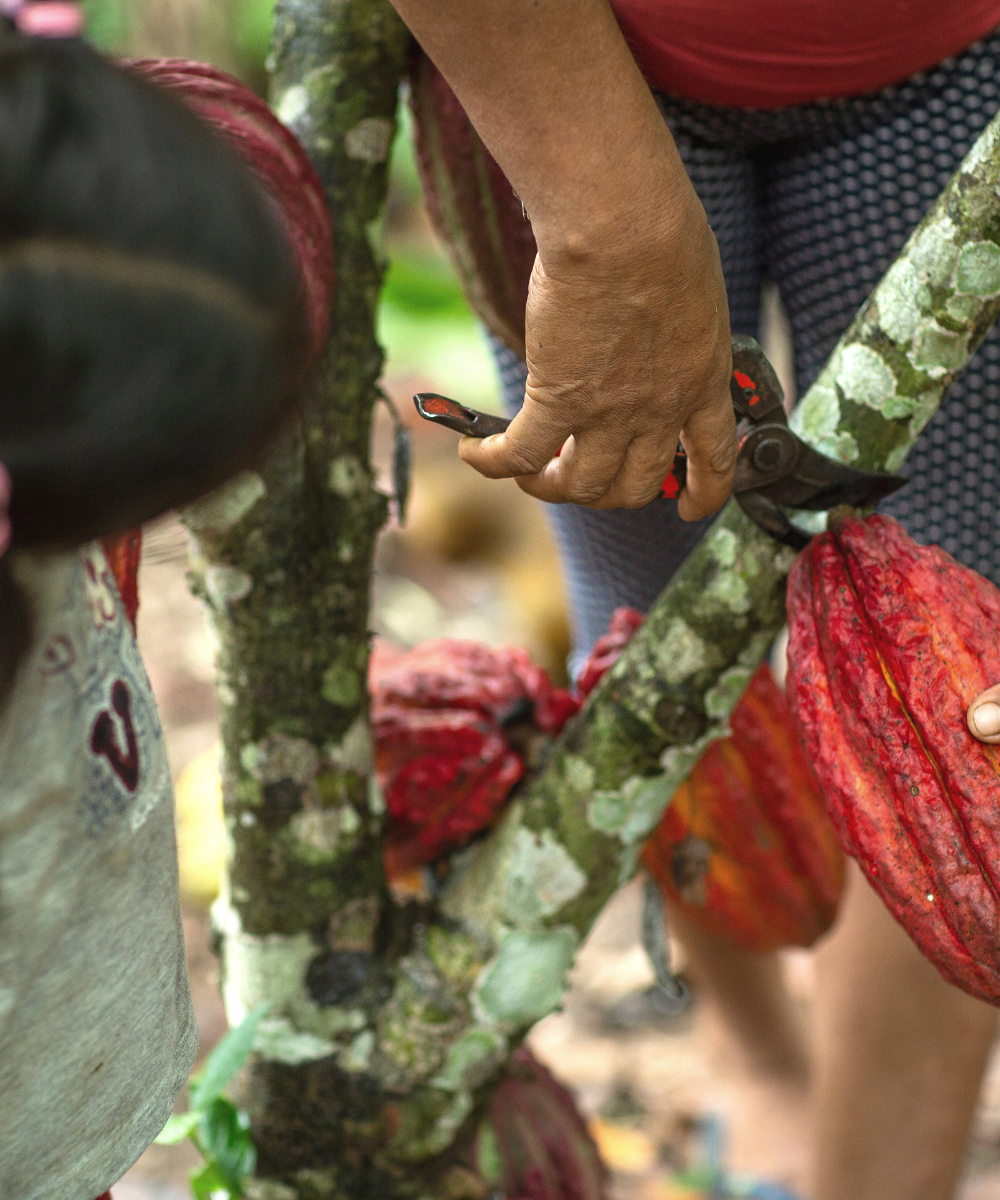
186,0,409,1200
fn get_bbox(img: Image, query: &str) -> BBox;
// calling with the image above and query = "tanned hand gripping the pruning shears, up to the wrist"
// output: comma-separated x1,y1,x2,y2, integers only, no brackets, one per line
460,188,737,521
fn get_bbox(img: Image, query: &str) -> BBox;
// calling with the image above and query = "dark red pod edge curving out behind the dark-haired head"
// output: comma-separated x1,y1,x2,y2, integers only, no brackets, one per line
122,59,334,359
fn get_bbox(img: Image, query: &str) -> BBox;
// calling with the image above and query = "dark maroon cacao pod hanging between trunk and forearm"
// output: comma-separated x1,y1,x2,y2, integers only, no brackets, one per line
409,53,535,359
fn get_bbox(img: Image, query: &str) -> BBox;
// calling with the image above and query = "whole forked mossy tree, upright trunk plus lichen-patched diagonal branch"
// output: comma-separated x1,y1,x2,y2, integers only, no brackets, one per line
188,16,1000,1200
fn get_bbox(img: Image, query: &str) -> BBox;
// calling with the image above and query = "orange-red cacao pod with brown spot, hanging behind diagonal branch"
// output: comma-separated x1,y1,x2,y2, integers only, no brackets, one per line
642,664,844,953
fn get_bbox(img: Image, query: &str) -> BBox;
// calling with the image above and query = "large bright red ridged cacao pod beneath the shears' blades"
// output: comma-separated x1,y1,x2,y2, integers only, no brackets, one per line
788,515,1000,1004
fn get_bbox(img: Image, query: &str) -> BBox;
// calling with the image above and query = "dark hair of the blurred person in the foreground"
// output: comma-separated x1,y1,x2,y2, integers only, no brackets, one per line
0,34,307,703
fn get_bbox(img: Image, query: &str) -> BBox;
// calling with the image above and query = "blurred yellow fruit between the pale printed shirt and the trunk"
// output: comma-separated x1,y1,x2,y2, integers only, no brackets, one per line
174,743,226,906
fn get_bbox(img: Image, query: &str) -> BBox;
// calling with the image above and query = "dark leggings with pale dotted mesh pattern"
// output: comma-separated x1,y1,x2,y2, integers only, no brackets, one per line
495,31,1000,665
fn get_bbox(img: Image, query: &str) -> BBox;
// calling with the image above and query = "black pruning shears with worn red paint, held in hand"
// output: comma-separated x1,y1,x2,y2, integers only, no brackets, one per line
413,335,906,550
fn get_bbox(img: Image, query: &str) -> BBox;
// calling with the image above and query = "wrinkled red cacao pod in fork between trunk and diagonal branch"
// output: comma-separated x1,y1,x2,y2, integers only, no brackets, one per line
369,638,579,878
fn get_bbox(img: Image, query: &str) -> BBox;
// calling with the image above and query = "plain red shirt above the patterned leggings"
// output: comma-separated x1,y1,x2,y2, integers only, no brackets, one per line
611,0,1000,108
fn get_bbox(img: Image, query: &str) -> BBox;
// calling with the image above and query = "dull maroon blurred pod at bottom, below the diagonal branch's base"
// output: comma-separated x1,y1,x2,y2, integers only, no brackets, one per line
477,1046,607,1200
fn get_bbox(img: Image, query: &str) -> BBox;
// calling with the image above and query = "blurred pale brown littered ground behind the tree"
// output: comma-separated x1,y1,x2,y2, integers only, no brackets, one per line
114,380,1000,1200
